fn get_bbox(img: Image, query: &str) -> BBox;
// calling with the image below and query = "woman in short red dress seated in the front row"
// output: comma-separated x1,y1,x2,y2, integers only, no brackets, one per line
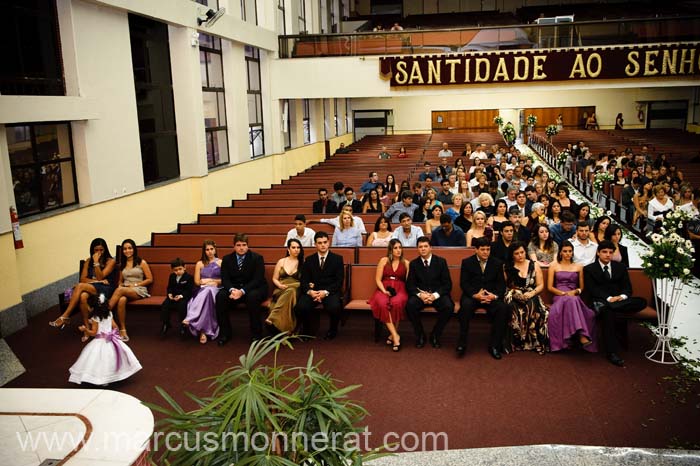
369,239,408,351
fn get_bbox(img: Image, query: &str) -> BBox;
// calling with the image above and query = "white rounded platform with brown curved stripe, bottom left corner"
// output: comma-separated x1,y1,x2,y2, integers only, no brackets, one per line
0,388,153,466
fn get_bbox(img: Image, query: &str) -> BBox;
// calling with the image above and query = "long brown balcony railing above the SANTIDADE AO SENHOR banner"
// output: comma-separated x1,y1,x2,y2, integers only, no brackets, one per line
279,16,700,58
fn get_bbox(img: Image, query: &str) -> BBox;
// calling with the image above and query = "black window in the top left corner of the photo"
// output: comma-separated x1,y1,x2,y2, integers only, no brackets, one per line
0,0,66,95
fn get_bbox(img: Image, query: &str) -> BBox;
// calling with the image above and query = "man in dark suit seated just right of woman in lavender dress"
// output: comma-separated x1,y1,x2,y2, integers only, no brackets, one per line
216,233,267,346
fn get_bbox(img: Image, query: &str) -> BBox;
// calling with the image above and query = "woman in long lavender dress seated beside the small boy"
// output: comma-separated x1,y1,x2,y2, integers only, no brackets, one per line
182,239,221,344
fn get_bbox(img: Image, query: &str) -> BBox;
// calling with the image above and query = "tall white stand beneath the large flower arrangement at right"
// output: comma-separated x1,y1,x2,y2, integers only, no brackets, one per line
645,278,683,364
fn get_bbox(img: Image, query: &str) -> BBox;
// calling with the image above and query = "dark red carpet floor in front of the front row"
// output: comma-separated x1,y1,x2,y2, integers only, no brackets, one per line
7,310,700,449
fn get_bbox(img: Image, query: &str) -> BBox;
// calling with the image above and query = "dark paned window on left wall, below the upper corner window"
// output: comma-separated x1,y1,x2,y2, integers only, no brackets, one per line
5,122,78,217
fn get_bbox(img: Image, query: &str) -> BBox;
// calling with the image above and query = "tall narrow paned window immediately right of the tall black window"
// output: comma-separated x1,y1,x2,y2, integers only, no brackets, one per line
199,33,229,168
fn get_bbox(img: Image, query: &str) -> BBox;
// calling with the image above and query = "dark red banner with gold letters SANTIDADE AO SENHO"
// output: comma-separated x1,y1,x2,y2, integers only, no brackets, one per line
379,42,700,87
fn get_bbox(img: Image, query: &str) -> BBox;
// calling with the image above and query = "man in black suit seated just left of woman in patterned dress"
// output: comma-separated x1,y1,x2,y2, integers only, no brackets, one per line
457,237,513,359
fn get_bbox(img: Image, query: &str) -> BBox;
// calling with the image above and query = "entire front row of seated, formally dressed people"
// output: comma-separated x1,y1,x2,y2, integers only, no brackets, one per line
51,231,647,366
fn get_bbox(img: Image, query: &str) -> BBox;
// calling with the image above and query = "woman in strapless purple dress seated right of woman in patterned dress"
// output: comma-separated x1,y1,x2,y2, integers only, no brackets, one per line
547,241,597,352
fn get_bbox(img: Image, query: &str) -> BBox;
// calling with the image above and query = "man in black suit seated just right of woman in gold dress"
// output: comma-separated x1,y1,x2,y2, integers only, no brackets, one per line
294,231,344,340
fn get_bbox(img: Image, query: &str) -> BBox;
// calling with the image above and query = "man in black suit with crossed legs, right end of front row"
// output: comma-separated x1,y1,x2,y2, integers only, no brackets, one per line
583,240,647,366
